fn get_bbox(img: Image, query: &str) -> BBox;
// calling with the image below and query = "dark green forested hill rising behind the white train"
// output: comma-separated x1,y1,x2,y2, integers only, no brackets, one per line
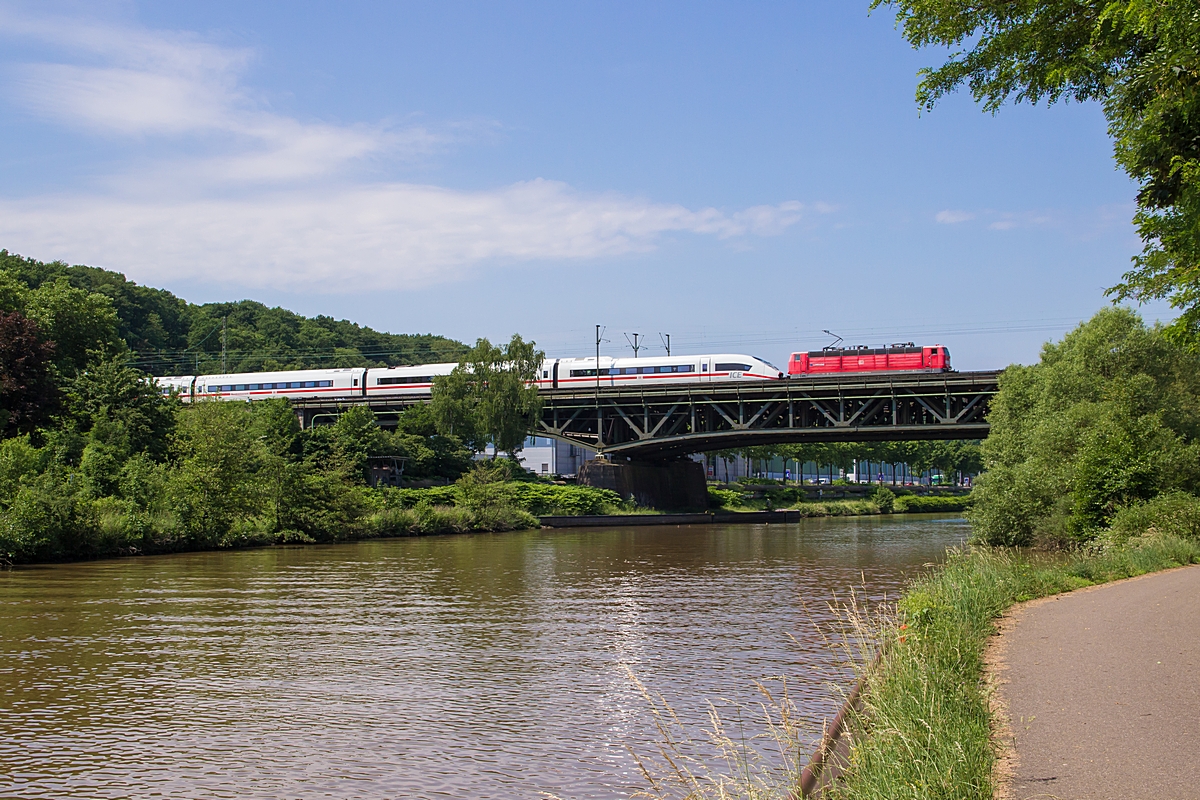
0,249,467,375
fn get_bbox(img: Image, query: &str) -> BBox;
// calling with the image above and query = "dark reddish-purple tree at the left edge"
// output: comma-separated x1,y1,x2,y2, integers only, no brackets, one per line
0,311,59,438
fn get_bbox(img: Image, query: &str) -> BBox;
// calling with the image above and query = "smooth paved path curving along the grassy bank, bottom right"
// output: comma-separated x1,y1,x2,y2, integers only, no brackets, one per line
994,566,1200,800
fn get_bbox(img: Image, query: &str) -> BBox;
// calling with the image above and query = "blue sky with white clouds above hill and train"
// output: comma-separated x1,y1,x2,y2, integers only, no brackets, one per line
0,0,1171,369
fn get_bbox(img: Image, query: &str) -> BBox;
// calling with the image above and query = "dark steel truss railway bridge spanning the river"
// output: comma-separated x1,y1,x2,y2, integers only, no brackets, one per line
295,372,1000,459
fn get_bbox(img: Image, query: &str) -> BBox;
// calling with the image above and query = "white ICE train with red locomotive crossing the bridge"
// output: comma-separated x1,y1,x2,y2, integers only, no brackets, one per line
155,342,950,402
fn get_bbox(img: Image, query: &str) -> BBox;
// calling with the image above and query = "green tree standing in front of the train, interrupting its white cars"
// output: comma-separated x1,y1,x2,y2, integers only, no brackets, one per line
432,335,546,458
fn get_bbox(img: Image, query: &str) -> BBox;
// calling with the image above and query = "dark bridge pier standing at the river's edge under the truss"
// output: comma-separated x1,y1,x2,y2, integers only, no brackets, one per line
578,458,708,511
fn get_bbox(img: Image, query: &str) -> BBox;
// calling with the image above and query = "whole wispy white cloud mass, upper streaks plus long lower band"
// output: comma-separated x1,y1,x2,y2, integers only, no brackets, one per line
0,10,832,290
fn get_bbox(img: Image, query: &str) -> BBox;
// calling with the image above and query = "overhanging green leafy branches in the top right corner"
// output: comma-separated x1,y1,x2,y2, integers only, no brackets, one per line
871,0,1200,344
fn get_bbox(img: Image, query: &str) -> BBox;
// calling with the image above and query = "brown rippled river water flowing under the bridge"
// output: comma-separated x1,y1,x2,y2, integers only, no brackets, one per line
0,516,967,800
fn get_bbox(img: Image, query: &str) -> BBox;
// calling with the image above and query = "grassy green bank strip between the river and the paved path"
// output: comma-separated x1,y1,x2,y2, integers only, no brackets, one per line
828,536,1200,800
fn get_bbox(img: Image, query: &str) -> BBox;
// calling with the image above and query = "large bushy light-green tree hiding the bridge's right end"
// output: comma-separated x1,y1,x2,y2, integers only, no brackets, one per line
971,308,1200,545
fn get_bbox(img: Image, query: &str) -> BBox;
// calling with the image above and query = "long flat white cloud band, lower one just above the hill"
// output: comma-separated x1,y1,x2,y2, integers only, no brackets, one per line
0,180,809,291
